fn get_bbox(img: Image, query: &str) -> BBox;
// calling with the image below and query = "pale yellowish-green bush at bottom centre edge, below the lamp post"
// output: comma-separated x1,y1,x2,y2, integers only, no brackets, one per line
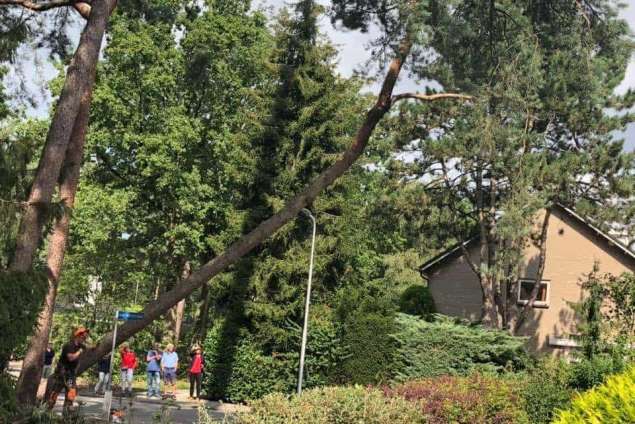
206,386,425,424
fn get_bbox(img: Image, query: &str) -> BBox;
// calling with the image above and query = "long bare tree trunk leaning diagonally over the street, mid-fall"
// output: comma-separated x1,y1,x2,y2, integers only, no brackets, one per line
79,36,412,372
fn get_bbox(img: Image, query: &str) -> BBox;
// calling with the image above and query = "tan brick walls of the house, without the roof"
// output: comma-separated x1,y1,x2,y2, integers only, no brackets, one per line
429,209,635,354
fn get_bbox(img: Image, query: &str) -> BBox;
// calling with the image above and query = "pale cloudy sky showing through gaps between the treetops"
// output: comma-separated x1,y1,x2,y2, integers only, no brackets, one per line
5,0,635,151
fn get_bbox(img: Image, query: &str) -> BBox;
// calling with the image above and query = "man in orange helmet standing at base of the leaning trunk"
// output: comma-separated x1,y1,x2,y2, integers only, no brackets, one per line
44,327,88,409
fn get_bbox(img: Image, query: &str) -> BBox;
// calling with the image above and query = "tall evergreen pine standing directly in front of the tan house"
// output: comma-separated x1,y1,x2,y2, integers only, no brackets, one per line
395,1,633,331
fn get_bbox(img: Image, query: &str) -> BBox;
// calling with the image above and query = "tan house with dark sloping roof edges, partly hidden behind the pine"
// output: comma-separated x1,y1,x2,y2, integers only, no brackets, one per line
421,206,635,355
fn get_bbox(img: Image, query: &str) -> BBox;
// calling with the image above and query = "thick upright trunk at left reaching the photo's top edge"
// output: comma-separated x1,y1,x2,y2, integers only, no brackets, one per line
9,0,116,272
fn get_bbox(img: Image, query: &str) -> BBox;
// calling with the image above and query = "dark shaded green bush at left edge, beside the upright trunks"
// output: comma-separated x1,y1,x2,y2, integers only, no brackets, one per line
0,271,48,371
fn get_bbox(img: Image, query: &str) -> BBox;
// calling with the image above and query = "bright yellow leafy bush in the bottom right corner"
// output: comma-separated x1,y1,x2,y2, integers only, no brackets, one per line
554,367,635,424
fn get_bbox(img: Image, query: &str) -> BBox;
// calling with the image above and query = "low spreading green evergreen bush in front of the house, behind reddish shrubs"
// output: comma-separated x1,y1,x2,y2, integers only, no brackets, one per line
392,314,530,381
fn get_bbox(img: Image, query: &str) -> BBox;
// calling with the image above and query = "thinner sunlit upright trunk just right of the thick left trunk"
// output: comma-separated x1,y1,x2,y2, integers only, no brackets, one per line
16,91,91,405
